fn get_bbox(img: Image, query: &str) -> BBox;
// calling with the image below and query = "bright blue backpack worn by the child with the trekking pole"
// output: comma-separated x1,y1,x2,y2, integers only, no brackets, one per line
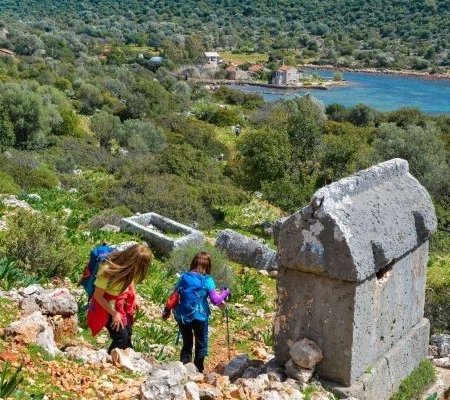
174,272,210,324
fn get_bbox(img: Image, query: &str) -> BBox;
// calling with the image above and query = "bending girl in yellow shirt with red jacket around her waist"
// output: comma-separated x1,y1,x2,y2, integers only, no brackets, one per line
87,244,153,353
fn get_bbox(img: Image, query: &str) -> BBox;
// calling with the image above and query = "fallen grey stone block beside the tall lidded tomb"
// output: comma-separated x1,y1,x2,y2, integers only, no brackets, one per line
216,229,278,271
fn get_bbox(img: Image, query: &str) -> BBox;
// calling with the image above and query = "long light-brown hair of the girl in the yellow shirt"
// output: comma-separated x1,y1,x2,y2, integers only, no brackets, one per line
102,244,153,292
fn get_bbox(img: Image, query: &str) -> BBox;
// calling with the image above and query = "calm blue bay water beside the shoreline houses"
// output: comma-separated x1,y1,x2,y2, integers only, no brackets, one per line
231,70,450,114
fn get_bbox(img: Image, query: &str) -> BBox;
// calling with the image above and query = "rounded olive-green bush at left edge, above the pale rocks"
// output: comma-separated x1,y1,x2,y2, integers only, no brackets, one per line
1,209,76,279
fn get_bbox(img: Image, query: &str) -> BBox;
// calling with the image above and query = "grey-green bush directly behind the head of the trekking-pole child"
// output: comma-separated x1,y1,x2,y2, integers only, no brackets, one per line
166,244,235,288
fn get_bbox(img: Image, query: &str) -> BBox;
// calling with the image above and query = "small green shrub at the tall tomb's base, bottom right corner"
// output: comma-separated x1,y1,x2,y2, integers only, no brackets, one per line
391,359,436,400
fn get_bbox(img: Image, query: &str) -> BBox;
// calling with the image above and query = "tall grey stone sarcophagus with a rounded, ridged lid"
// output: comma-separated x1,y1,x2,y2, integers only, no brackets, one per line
275,159,436,400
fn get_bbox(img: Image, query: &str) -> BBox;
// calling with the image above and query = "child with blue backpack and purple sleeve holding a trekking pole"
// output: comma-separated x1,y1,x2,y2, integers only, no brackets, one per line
162,251,230,372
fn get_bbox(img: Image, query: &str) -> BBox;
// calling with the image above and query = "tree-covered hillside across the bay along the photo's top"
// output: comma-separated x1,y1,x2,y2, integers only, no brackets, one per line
1,0,450,72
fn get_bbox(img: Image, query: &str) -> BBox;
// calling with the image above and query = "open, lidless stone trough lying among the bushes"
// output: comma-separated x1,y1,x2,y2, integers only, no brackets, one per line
120,212,204,256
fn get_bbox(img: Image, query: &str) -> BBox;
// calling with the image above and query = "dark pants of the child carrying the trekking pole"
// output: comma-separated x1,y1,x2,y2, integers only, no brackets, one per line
178,319,208,372
